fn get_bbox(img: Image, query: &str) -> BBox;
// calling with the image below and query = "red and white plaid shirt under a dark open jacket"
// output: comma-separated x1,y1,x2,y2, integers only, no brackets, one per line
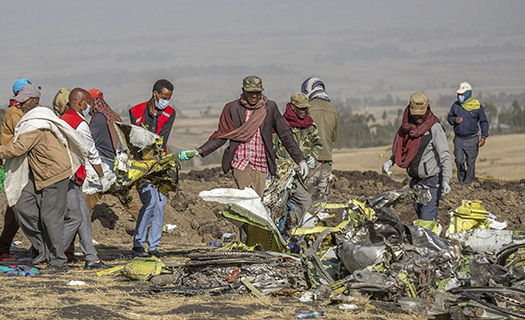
232,109,268,172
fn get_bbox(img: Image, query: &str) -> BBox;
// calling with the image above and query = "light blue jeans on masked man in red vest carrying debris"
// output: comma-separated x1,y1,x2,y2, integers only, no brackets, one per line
133,182,166,251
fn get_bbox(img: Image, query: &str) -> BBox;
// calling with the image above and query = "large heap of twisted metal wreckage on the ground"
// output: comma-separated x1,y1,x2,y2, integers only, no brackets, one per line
104,160,525,319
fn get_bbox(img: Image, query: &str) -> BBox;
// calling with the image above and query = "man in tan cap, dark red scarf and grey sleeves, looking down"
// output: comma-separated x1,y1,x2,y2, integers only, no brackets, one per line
383,92,452,232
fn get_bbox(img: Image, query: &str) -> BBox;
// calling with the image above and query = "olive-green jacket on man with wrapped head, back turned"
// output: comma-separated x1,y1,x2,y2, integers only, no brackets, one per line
309,99,339,161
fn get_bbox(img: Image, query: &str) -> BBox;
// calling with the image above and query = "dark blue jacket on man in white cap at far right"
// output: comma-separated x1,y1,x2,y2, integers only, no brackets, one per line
447,101,489,139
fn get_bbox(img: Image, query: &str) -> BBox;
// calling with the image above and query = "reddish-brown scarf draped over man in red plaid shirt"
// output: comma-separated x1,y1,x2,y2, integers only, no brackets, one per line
210,95,268,143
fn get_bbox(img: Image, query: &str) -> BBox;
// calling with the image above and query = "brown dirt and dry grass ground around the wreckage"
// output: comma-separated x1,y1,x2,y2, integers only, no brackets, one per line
0,168,525,319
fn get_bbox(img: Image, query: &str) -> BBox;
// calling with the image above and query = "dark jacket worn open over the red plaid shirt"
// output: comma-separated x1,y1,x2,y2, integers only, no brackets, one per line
199,99,304,175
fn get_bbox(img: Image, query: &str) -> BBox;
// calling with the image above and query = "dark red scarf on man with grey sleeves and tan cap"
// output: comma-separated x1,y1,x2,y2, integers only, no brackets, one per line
392,106,439,168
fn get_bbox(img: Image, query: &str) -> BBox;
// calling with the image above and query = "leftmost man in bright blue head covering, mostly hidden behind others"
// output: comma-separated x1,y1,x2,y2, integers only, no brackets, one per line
0,78,32,261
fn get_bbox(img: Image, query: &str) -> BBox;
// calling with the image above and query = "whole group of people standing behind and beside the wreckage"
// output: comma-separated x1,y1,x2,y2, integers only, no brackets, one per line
0,76,488,272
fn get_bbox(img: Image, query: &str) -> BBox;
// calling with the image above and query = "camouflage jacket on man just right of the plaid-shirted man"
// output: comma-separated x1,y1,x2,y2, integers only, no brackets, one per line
273,123,323,159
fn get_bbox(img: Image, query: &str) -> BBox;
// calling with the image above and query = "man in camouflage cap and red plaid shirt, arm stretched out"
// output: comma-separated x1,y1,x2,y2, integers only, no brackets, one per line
179,76,308,198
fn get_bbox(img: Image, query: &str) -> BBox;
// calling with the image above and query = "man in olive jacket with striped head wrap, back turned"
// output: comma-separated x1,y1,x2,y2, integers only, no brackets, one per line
301,77,339,204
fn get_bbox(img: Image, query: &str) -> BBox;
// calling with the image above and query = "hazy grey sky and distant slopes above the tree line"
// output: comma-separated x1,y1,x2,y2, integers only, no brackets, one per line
0,0,525,114
